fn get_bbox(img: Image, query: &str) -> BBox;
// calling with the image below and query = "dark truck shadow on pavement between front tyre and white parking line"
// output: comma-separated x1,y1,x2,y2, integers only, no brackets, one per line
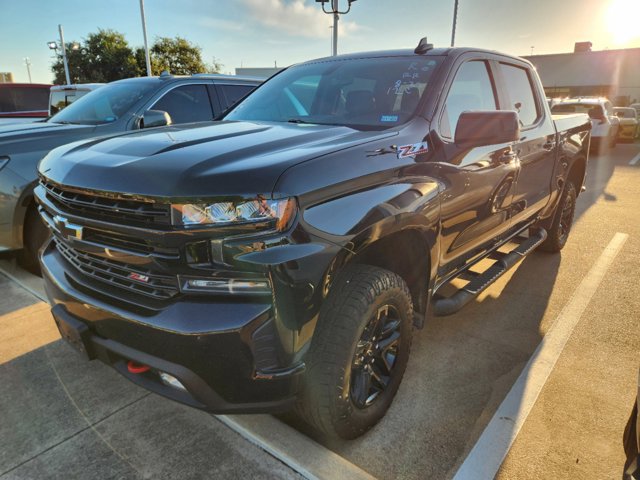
284,253,561,479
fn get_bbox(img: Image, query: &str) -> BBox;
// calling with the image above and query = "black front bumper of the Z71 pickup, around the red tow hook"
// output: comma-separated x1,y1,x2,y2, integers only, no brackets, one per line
41,242,304,413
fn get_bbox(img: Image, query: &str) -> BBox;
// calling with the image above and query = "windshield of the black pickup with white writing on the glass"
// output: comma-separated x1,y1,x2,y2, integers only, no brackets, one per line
224,55,441,130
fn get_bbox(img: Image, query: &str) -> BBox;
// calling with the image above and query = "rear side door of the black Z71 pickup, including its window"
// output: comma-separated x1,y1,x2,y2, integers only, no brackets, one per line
495,61,556,226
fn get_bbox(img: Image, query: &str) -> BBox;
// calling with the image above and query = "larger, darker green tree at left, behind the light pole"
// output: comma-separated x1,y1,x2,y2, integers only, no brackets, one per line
51,29,141,84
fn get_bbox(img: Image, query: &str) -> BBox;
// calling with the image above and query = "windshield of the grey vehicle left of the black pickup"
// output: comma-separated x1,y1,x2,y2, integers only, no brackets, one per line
48,81,156,125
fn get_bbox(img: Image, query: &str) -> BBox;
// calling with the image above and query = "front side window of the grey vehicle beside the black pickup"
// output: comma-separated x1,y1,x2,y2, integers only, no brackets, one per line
151,85,213,123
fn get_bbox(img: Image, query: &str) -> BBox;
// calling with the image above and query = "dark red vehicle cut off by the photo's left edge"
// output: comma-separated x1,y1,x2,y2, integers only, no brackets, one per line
0,83,51,125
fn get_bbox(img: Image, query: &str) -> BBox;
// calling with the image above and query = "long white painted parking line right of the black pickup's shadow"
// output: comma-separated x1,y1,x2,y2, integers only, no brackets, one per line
453,233,629,480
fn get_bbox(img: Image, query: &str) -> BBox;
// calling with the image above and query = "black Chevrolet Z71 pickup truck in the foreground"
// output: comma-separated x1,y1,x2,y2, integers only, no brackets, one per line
35,39,591,438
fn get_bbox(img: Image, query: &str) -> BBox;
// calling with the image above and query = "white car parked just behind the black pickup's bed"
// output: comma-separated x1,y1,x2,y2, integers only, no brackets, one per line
551,97,620,148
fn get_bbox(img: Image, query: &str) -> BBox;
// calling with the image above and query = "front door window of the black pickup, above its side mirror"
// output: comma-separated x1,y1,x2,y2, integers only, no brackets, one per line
440,60,498,138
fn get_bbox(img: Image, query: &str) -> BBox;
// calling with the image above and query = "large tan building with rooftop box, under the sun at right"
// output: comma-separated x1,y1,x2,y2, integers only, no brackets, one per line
524,42,640,106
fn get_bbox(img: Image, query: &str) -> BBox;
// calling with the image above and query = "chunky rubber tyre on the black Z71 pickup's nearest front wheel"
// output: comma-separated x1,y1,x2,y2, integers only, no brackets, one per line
296,265,413,439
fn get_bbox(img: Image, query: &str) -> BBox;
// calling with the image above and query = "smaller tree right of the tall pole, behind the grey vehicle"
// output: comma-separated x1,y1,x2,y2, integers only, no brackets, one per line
136,37,221,75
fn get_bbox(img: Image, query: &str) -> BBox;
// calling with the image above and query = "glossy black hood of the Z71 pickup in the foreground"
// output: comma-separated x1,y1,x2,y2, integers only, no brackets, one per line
40,122,397,201
